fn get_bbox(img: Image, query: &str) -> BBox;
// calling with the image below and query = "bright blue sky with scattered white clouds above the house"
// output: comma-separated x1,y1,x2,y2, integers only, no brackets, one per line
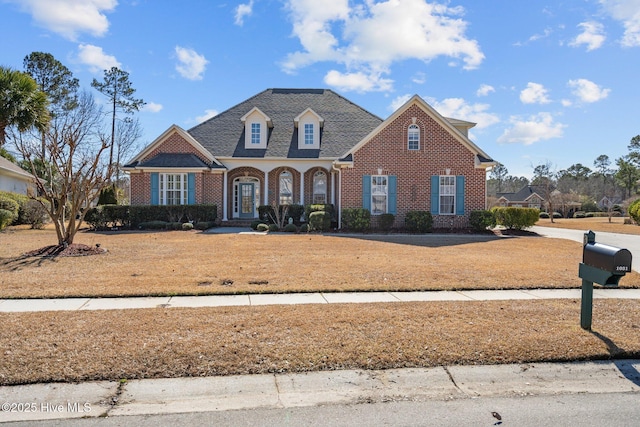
0,0,640,176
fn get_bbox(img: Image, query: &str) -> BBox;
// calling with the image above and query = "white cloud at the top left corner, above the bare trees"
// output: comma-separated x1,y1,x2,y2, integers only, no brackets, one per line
9,0,118,41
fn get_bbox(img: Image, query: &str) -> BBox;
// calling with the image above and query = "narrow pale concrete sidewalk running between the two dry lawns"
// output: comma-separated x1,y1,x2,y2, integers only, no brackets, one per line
0,288,640,313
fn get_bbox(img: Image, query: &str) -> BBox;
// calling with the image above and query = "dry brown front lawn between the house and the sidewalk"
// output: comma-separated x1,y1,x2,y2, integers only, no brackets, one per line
0,229,640,298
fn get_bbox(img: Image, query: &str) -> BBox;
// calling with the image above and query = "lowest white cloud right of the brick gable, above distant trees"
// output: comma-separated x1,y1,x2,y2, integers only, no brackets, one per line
498,112,566,145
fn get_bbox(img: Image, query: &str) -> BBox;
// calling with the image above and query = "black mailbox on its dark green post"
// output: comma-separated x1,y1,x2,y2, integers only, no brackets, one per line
578,230,631,330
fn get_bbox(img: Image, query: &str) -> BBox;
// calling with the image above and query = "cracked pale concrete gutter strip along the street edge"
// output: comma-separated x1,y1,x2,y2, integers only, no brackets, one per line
0,360,640,423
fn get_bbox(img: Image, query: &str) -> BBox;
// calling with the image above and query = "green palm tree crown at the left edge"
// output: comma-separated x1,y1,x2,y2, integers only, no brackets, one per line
0,66,49,147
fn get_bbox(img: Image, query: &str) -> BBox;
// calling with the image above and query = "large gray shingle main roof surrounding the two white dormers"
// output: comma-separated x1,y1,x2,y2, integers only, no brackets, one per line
188,89,382,159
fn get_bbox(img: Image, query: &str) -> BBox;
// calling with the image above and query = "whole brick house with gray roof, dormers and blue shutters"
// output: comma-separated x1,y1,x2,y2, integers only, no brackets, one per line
124,89,495,227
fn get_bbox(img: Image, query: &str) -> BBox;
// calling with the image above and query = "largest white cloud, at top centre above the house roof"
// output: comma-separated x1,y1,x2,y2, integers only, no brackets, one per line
282,0,484,90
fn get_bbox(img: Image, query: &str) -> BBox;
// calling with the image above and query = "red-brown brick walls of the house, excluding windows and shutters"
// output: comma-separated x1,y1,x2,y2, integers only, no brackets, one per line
130,95,486,228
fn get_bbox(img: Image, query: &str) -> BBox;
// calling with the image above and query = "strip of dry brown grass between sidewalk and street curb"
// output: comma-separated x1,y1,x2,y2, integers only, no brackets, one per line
0,300,640,385
